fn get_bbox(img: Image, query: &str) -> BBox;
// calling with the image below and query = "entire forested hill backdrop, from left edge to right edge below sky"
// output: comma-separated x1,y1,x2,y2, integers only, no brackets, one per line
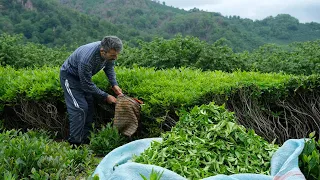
0,0,320,51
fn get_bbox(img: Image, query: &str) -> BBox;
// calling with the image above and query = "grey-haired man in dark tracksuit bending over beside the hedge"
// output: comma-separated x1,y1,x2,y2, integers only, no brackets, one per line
60,36,122,145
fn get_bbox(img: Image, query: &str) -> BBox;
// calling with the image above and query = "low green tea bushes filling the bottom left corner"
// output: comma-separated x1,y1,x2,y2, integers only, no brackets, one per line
0,130,97,179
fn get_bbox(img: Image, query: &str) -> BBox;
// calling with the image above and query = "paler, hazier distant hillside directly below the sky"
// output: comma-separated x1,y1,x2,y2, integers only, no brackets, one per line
57,0,320,51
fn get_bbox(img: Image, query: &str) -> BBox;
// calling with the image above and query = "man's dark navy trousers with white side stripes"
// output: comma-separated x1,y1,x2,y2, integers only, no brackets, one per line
60,70,94,144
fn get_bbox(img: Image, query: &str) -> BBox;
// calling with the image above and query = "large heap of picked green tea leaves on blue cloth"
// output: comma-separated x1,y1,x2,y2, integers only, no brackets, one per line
134,103,278,179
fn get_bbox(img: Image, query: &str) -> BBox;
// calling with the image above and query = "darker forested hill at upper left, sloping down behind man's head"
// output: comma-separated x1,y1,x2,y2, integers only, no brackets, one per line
0,0,142,47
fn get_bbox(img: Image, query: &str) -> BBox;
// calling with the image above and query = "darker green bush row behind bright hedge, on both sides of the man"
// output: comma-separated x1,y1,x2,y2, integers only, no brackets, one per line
0,34,320,75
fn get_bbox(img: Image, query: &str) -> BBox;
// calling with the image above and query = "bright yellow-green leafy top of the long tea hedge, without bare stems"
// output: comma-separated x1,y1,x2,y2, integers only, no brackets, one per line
0,67,320,140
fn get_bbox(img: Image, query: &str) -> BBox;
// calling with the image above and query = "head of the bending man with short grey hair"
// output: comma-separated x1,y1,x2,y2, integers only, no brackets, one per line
100,36,122,61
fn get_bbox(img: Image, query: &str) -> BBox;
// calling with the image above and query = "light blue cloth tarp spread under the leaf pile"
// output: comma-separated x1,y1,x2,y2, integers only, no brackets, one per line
93,138,305,180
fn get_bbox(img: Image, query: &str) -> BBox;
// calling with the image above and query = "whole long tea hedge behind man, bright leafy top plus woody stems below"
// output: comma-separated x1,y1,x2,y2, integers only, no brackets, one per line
0,67,320,143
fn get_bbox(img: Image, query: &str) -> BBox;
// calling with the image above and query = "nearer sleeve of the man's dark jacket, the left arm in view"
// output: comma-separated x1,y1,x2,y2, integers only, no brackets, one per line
78,63,108,99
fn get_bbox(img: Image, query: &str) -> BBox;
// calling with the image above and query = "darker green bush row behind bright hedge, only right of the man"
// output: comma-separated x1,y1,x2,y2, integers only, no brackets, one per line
119,35,320,75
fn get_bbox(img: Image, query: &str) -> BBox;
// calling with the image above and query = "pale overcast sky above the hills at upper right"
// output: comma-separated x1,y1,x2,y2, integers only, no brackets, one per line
160,0,320,23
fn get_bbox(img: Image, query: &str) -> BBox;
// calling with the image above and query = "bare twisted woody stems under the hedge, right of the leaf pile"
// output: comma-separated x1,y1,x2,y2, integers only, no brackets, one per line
229,90,320,144
